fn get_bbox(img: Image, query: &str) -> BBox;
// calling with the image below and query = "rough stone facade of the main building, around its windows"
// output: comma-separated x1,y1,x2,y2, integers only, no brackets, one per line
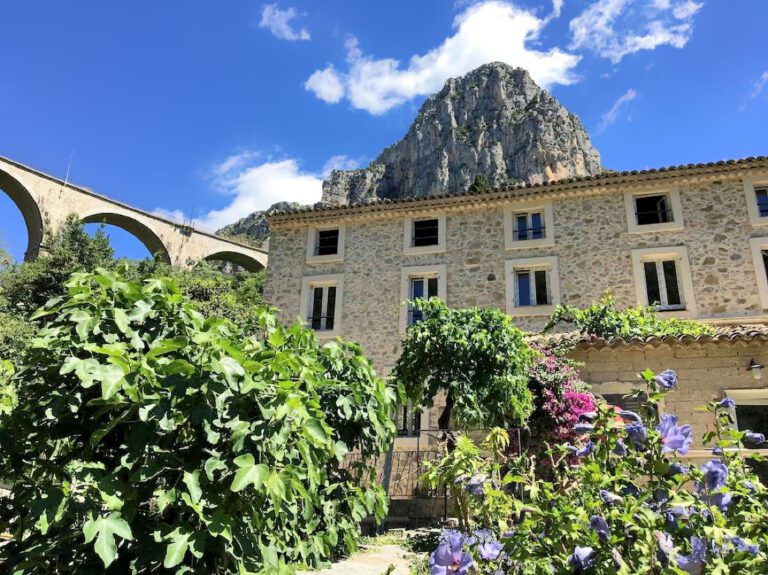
265,158,768,371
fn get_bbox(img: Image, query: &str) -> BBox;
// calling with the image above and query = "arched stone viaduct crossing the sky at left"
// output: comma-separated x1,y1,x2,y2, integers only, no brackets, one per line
0,157,267,271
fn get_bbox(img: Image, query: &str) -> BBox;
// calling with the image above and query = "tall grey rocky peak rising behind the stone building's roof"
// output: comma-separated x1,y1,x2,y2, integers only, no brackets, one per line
322,62,601,205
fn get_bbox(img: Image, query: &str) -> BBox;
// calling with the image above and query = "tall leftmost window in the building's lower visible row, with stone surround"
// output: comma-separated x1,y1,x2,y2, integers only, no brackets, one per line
300,274,344,337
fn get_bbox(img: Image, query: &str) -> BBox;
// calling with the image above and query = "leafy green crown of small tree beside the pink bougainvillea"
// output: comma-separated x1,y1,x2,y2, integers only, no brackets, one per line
393,298,533,428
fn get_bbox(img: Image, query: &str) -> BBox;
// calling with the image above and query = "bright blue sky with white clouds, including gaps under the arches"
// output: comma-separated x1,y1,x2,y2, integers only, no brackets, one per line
0,0,768,257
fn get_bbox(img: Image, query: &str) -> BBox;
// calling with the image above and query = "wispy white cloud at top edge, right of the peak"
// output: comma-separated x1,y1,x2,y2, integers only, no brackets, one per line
570,0,703,64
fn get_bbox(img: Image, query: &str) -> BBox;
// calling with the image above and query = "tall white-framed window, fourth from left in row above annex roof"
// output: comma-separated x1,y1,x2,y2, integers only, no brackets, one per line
632,246,695,317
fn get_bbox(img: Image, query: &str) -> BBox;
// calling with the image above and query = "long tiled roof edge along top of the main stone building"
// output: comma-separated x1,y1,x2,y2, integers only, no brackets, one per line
268,156,768,223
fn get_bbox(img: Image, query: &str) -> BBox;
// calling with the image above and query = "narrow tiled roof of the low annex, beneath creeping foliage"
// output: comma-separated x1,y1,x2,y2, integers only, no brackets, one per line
532,324,768,350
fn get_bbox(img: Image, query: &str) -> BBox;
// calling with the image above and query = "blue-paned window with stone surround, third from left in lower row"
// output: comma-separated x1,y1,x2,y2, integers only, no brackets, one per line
505,257,560,315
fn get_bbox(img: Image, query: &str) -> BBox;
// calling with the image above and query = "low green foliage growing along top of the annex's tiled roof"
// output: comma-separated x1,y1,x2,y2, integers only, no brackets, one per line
544,294,714,339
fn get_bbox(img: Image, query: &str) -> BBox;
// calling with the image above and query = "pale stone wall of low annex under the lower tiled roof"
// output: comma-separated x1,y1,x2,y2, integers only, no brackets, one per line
572,342,768,457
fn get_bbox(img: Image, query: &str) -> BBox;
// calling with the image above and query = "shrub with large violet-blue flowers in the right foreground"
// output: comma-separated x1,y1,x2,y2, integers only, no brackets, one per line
420,371,768,575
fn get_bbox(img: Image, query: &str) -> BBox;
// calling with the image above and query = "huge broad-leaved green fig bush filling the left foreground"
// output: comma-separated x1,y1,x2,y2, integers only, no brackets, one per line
0,270,396,575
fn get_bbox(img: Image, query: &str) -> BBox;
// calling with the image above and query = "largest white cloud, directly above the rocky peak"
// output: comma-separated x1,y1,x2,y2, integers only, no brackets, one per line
305,0,580,114
